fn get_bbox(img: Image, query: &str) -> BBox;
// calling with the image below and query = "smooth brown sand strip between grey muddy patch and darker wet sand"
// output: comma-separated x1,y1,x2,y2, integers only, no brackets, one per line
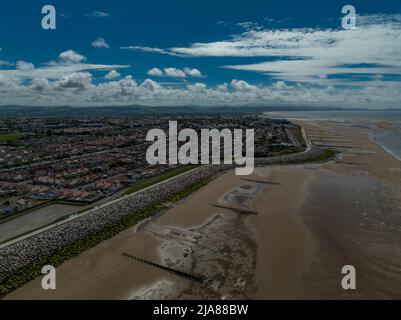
247,166,313,299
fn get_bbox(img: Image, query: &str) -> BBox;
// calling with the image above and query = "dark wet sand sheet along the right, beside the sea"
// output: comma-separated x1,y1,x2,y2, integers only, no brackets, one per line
299,122,401,299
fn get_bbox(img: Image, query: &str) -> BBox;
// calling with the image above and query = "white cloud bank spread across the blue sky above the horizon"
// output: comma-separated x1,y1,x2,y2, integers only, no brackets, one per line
0,15,401,108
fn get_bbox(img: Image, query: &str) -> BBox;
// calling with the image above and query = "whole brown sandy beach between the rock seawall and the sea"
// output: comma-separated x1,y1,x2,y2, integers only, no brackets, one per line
5,121,401,299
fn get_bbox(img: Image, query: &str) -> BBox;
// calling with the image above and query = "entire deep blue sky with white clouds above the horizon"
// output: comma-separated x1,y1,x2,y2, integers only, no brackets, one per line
0,0,401,108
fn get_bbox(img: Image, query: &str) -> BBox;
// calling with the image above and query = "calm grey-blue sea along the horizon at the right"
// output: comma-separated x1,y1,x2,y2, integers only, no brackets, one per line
266,110,401,160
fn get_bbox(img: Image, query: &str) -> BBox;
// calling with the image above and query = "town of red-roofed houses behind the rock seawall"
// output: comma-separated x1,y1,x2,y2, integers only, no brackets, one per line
0,114,300,218
